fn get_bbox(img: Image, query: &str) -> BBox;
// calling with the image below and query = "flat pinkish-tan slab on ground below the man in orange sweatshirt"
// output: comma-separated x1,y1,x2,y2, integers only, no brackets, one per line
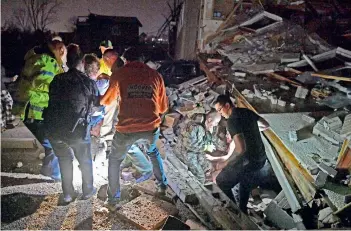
117,195,178,230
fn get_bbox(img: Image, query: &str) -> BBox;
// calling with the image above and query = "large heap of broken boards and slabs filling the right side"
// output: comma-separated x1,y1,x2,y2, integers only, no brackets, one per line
195,3,351,229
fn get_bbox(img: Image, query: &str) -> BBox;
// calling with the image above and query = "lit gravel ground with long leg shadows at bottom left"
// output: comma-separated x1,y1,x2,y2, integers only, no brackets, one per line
1,173,139,230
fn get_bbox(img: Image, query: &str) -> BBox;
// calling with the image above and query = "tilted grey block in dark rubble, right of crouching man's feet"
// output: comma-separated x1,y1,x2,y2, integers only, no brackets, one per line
263,201,296,229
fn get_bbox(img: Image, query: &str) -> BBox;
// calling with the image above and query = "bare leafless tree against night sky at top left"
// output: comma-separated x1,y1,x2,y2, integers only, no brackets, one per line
15,0,61,31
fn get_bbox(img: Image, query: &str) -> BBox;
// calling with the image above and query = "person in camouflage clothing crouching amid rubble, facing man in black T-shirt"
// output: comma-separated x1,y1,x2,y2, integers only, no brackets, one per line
175,112,221,183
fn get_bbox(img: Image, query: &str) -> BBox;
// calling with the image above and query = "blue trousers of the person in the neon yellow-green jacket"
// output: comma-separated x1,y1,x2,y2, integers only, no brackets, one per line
24,120,60,177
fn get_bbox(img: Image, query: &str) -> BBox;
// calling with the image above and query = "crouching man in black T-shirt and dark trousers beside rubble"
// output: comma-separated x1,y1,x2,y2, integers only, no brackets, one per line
206,95,269,213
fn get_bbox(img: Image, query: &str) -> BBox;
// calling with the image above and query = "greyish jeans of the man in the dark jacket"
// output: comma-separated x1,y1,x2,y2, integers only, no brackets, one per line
50,138,94,196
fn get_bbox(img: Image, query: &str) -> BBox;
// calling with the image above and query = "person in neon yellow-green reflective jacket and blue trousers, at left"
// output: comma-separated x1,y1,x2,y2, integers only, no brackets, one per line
19,40,67,180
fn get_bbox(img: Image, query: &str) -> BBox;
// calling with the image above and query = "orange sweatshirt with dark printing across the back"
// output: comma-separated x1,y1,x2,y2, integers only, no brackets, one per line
102,62,168,133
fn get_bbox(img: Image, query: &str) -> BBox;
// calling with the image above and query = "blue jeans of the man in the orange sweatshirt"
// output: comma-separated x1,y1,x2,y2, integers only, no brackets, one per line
107,128,167,200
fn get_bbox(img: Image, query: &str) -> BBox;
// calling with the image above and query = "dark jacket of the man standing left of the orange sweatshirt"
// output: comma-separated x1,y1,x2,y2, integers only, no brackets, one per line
44,68,100,140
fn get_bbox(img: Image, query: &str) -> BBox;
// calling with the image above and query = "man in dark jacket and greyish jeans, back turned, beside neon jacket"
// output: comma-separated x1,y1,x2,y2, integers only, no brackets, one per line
44,45,100,203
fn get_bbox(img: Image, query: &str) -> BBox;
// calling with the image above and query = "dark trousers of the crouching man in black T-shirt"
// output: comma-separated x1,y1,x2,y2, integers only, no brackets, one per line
216,160,271,213
